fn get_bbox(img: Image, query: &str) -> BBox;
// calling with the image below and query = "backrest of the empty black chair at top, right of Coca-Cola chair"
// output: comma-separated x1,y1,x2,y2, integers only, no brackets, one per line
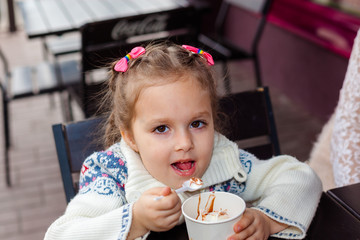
215,0,273,53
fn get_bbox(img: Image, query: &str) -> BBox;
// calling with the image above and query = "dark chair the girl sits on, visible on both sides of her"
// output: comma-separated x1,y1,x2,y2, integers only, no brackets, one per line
53,87,280,202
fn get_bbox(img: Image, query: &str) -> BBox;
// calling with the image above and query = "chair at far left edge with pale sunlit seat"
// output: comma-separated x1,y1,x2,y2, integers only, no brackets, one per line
0,49,79,186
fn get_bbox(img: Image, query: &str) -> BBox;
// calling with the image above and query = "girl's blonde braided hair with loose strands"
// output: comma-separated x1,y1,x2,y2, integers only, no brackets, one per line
102,42,217,147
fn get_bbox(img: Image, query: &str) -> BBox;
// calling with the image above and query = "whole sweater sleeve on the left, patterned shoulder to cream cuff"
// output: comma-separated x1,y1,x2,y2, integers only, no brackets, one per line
45,151,146,240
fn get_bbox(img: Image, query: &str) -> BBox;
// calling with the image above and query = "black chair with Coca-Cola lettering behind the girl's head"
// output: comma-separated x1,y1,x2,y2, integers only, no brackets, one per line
66,6,201,118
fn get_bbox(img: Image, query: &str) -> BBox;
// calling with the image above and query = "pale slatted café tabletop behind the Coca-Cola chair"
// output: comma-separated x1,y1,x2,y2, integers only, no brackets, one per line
17,0,201,38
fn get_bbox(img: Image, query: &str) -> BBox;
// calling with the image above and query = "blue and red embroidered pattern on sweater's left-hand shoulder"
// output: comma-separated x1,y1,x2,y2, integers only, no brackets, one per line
79,145,128,197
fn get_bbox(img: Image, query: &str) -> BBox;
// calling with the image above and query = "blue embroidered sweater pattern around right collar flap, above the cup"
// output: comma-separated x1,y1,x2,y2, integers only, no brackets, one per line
209,149,254,195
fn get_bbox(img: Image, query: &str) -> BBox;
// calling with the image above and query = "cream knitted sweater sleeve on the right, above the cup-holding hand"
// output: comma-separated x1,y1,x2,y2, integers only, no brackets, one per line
240,150,322,239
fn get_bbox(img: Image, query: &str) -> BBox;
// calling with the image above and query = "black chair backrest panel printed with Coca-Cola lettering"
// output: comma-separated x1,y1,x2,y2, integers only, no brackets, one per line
81,6,200,71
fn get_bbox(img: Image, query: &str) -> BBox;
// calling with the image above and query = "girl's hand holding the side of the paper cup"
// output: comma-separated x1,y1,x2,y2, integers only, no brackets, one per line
228,208,288,240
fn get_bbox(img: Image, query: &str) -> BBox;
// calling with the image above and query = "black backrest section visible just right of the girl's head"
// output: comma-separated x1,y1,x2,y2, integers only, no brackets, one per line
219,87,280,159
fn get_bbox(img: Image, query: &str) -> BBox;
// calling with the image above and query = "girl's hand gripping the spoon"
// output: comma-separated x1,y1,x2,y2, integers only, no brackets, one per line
128,187,181,239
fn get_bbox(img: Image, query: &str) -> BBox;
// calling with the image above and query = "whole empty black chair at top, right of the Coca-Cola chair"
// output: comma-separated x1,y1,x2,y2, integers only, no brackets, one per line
199,0,272,93
